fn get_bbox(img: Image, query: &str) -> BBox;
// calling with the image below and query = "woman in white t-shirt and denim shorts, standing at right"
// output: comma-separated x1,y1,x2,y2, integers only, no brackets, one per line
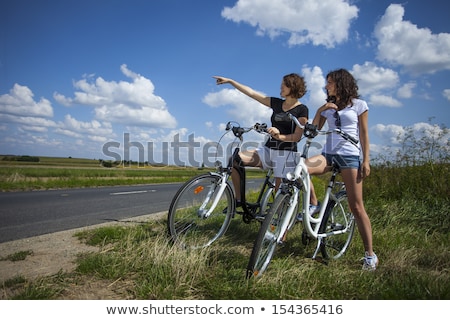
307,69,378,270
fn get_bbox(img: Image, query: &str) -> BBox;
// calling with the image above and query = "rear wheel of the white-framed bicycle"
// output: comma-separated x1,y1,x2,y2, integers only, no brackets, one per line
320,191,355,259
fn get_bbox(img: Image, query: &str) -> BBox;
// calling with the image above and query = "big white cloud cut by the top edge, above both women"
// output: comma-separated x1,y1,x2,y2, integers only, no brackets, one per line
222,0,358,48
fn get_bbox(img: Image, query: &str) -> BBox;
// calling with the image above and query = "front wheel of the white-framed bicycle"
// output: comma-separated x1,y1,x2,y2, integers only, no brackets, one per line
247,193,291,278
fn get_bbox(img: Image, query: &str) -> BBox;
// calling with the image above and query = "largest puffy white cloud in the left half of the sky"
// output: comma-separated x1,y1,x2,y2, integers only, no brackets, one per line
53,65,176,128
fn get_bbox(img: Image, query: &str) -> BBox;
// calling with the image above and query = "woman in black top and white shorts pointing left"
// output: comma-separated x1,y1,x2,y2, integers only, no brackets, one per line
214,73,308,204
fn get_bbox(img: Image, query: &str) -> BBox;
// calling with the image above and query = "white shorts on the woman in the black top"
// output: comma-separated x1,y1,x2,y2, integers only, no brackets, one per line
256,146,298,178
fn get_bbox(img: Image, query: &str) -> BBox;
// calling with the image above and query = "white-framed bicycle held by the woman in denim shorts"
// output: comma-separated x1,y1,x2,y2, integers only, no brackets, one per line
246,113,358,278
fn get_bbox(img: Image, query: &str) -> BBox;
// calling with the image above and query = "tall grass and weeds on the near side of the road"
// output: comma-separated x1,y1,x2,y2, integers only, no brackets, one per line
0,123,450,300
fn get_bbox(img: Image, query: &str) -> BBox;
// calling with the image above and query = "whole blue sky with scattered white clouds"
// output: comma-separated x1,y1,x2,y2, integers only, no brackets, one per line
0,0,450,166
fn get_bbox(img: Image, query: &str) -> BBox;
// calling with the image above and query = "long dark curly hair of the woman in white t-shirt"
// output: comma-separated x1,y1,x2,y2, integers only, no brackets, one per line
327,69,359,109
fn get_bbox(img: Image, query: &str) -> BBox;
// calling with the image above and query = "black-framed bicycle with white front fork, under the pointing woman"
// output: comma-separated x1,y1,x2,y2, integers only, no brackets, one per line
167,122,275,249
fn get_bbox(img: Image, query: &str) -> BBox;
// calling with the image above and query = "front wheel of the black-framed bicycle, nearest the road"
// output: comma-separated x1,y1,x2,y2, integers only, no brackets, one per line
167,173,234,249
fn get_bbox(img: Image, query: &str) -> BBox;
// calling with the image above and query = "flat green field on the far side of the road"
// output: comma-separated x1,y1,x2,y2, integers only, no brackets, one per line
0,156,264,191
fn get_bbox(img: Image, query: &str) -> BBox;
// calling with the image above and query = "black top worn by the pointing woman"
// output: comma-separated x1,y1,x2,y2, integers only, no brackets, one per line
265,97,308,151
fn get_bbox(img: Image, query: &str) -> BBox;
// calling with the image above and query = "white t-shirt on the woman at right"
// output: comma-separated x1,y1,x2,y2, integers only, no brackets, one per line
320,99,369,156
